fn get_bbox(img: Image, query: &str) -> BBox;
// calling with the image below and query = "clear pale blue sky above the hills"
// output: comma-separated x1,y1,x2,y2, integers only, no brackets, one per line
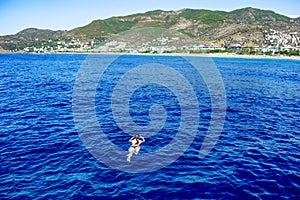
0,0,300,35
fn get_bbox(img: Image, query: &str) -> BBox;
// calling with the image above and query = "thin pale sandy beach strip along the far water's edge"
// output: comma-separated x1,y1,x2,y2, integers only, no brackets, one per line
0,52,300,60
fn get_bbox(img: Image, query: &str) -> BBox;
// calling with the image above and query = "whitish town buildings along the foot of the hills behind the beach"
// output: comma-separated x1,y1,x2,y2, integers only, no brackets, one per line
2,29,300,54
